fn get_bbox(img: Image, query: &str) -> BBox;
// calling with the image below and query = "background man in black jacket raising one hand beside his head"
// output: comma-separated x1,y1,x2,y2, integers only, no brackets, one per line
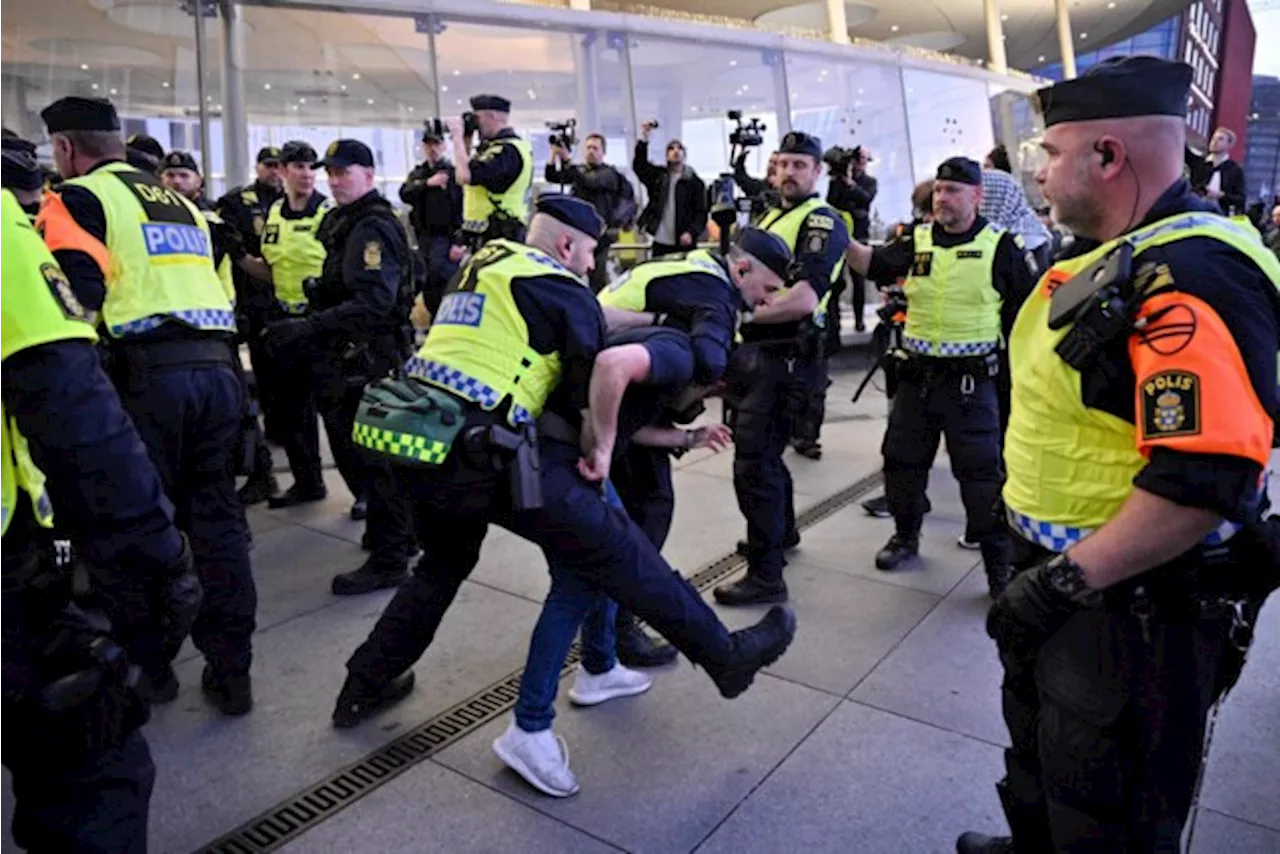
631,120,709,257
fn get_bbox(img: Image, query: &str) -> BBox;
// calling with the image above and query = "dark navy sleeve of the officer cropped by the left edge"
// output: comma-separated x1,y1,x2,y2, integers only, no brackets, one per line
0,341,182,574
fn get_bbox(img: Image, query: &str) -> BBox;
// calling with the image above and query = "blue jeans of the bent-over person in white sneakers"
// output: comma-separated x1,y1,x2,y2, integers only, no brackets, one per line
516,480,622,732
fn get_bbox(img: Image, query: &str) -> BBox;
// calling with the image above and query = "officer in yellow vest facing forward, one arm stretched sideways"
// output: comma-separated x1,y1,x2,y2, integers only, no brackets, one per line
849,157,1036,597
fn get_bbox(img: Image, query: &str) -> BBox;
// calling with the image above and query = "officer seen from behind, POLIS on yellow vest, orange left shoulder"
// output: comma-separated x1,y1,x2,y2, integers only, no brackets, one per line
38,96,257,714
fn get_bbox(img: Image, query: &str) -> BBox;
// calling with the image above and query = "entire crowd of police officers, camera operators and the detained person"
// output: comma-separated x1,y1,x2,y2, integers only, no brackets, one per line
0,50,1280,854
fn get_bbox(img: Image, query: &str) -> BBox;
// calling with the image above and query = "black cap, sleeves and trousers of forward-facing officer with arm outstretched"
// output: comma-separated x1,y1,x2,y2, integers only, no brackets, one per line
868,157,1036,595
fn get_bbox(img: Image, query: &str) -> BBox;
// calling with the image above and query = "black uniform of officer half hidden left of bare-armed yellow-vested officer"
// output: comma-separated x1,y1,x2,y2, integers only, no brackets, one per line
214,146,282,453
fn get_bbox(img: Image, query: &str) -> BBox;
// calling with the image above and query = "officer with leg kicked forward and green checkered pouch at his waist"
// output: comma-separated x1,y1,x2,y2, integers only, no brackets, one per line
334,196,795,727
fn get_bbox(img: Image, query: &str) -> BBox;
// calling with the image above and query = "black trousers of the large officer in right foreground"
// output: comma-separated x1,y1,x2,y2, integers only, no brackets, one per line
997,552,1239,854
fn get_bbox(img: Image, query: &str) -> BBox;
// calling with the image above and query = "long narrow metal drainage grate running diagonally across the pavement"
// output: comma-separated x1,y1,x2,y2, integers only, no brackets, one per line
197,472,883,854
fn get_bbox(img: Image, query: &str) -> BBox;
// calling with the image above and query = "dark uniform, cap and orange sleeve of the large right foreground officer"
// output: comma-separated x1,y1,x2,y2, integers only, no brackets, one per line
957,56,1280,854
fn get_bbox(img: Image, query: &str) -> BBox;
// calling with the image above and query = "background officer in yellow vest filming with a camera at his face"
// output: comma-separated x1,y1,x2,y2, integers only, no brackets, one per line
448,95,534,253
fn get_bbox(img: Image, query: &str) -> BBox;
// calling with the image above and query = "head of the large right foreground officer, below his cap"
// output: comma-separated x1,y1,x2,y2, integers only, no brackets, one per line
1036,115,1187,241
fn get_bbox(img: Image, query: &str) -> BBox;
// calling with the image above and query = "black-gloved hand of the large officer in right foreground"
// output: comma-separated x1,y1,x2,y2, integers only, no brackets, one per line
987,554,1102,656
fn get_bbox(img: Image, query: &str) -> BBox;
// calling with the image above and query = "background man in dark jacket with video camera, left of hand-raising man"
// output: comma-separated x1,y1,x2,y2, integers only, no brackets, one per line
547,133,636,293
